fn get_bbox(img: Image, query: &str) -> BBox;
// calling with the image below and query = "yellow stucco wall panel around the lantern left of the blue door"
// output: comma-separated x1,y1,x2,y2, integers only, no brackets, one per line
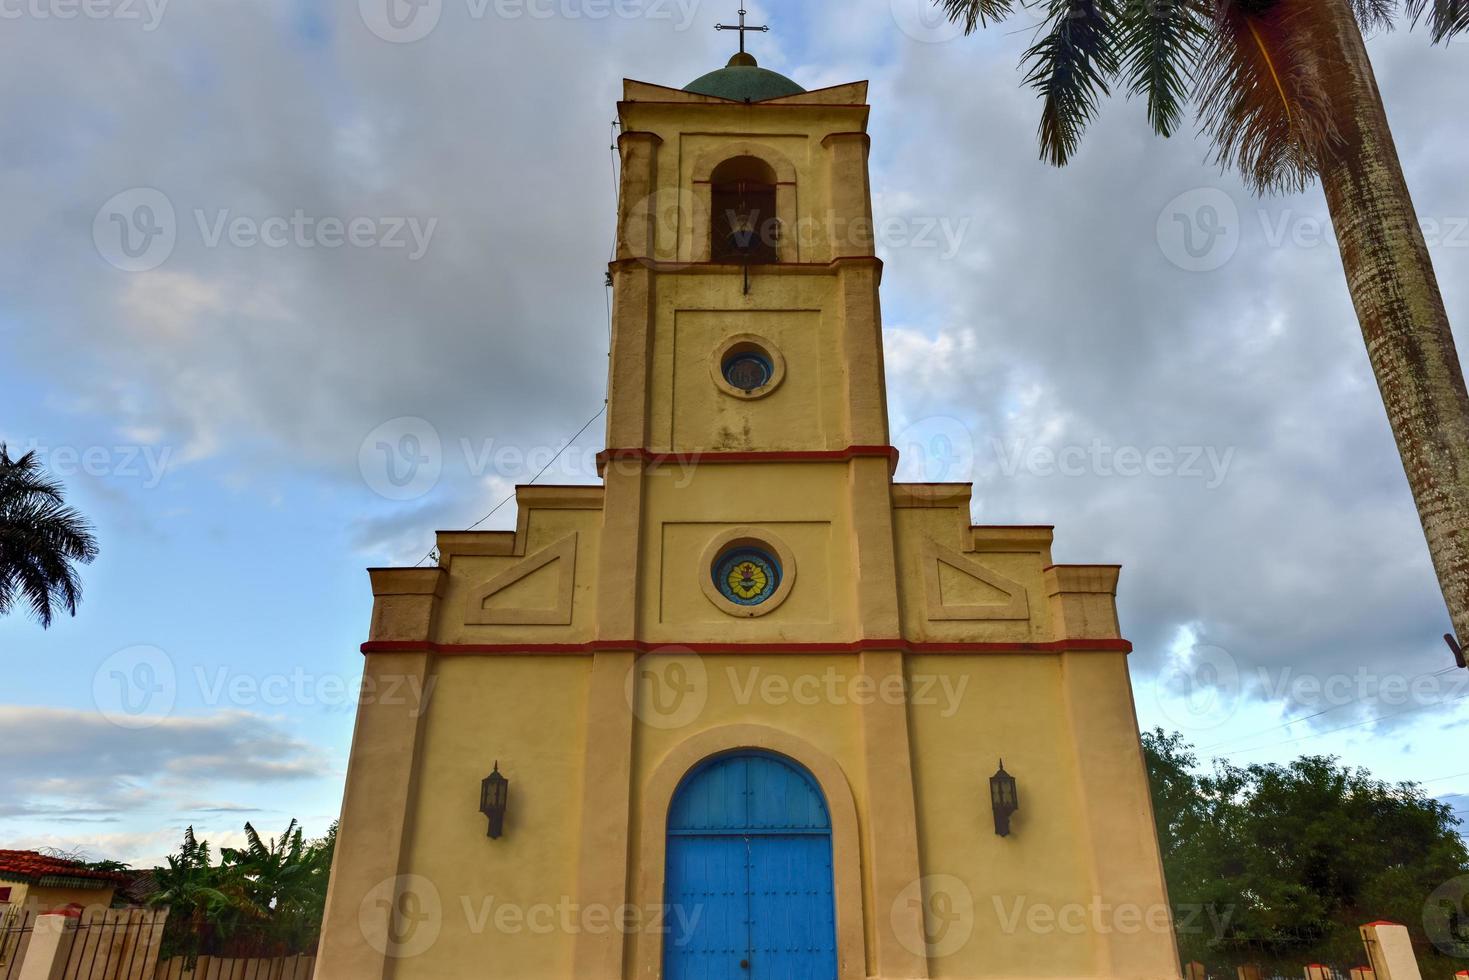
397,657,591,979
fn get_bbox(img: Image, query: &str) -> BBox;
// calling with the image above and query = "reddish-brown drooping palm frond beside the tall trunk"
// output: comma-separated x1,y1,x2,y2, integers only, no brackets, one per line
1197,0,1340,192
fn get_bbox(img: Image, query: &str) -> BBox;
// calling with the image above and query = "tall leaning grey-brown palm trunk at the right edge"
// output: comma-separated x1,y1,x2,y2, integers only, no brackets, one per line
1312,0,1469,658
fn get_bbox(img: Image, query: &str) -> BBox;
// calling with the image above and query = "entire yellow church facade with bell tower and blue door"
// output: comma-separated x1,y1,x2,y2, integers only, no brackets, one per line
316,51,1178,980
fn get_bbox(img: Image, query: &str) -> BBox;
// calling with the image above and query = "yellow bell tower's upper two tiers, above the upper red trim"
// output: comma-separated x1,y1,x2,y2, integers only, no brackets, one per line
607,53,887,458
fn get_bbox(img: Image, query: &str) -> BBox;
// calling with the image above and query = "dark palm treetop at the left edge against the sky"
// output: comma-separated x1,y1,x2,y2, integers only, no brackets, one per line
0,442,97,627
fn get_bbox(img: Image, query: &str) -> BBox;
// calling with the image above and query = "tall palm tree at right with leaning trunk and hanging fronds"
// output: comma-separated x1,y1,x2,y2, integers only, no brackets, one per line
936,0,1469,644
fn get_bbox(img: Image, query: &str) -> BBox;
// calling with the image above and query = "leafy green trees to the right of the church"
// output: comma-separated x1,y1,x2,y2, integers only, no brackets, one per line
1143,729,1469,976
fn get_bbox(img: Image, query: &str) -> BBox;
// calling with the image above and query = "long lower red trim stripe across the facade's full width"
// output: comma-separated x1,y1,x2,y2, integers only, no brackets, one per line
361,638,1133,657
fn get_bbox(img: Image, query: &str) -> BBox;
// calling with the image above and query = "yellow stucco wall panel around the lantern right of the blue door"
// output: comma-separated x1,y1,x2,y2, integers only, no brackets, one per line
908,655,1105,977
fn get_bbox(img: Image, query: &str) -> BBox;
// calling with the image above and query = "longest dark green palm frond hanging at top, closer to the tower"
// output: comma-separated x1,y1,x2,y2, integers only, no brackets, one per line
1021,0,1119,166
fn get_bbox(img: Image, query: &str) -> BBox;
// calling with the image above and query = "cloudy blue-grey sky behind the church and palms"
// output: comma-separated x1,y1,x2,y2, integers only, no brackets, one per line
0,0,1469,861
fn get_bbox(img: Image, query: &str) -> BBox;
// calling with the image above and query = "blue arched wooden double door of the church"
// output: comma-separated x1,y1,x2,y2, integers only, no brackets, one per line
663,752,836,980
